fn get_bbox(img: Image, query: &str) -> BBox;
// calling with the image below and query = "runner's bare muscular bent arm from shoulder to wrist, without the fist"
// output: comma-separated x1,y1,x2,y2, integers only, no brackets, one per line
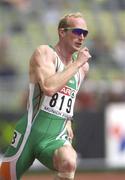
31,46,91,96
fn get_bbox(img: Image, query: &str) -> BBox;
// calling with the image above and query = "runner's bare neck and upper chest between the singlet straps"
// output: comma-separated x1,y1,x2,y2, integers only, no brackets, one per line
55,44,72,65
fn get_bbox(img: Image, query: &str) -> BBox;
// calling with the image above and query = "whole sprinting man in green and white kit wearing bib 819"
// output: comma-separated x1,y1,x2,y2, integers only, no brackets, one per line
0,13,91,180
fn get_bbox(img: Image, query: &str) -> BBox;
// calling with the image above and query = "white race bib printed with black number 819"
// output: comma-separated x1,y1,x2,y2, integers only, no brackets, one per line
41,86,76,118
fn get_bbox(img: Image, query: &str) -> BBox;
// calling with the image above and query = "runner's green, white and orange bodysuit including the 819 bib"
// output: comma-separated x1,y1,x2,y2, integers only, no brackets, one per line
1,45,81,180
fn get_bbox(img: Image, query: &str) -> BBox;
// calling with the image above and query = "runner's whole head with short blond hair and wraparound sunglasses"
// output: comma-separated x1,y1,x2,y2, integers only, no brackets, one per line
58,12,88,51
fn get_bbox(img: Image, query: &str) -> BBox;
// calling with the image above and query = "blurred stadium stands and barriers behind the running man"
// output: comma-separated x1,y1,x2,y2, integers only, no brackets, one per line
0,0,125,179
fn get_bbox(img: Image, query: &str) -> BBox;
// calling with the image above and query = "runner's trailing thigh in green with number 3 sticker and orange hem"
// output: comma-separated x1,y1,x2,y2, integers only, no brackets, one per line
1,118,34,180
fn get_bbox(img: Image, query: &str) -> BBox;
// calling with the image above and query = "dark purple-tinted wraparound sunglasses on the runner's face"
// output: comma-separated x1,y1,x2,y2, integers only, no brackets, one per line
64,27,88,37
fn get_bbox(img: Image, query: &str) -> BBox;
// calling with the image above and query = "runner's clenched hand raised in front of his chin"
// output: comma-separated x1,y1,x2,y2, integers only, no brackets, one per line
77,47,91,67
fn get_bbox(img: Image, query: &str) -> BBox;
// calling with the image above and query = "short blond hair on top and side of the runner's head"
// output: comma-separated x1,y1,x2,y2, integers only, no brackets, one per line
58,12,83,29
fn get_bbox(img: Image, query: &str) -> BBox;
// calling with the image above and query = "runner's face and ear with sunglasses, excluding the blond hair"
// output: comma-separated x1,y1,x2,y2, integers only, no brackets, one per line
60,18,88,52
